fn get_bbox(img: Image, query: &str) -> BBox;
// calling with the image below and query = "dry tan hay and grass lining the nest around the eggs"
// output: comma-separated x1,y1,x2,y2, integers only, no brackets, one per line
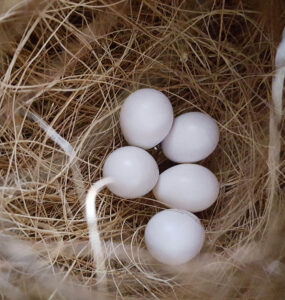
0,0,285,300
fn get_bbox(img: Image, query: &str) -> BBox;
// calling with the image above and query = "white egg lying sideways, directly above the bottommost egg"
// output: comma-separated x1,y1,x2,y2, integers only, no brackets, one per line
153,164,219,212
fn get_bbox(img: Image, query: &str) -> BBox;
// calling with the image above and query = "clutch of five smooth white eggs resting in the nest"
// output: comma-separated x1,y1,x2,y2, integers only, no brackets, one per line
103,89,219,265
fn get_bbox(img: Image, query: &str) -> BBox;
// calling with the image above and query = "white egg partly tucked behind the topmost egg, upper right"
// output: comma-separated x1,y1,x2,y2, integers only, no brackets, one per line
162,112,219,163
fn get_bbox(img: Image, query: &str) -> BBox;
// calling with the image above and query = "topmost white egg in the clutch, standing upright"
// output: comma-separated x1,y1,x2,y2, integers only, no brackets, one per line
120,89,173,149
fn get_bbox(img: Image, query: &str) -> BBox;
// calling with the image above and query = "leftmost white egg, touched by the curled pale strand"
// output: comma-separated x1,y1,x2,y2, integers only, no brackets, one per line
103,146,159,199
